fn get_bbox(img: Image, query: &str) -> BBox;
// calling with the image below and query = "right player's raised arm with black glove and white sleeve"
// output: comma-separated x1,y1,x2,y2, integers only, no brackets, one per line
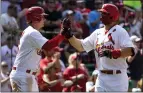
61,18,96,52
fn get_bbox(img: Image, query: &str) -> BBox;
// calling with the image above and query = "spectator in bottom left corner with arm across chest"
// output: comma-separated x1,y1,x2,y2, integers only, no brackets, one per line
0,61,11,92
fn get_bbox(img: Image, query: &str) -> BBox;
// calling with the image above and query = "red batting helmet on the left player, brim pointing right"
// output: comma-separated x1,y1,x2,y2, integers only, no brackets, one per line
26,6,48,23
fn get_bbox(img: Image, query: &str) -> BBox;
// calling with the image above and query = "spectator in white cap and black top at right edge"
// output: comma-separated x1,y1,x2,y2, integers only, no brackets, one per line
127,36,143,88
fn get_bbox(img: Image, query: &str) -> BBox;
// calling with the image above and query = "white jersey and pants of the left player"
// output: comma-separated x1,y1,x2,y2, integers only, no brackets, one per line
10,26,47,92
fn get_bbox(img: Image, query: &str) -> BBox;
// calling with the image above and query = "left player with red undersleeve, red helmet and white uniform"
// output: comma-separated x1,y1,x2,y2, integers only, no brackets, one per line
10,6,68,92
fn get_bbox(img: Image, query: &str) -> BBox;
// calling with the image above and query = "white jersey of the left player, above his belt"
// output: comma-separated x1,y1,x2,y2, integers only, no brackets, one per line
14,26,47,71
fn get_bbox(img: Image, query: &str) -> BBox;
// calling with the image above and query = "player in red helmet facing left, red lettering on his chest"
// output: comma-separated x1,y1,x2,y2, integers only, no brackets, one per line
61,4,134,92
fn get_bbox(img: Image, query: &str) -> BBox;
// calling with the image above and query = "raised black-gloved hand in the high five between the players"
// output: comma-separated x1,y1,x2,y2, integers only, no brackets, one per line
61,18,73,39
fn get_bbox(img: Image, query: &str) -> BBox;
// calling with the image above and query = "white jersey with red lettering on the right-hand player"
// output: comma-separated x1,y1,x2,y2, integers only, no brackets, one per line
81,25,133,70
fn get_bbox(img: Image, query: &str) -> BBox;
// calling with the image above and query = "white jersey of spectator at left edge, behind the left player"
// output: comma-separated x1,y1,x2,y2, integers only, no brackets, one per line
1,45,18,71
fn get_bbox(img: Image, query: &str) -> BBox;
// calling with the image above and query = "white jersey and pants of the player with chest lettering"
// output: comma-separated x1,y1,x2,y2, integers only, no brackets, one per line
81,25,133,92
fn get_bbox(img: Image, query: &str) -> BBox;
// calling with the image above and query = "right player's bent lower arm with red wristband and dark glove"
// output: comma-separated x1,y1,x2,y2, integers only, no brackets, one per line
99,29,135,59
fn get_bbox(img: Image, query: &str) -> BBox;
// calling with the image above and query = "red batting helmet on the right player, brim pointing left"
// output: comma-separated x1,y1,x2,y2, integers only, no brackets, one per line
99,4,119,21
